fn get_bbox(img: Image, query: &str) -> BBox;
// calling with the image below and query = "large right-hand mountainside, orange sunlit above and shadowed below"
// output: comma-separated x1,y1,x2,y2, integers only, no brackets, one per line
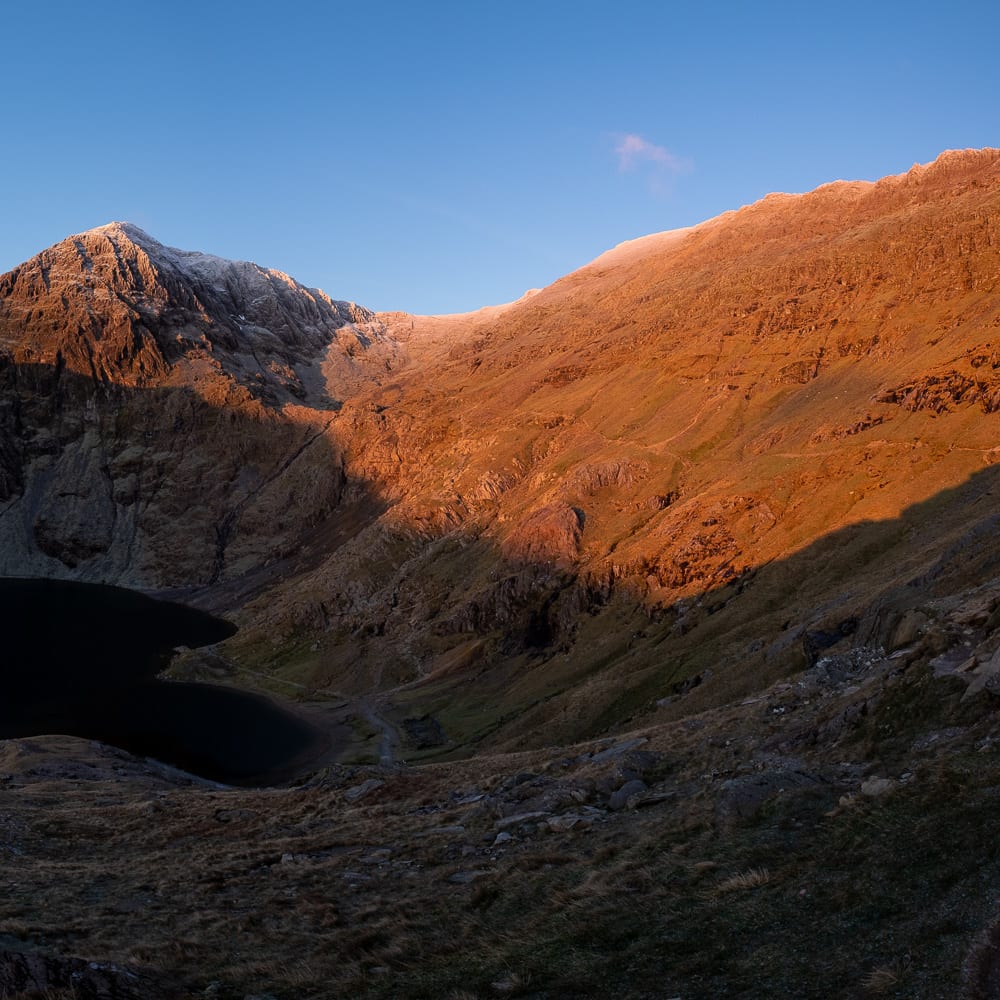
207,150,1000,743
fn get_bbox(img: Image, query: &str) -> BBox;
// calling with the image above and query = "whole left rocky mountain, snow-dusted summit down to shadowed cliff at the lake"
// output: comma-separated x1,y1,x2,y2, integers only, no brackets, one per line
0,223,399,587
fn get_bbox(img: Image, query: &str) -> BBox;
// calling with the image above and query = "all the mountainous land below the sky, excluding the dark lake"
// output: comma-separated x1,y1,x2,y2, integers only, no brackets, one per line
0,149,1000,1000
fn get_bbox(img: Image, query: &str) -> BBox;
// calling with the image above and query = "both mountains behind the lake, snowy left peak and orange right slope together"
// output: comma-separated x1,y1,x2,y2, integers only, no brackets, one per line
0,150,1000,749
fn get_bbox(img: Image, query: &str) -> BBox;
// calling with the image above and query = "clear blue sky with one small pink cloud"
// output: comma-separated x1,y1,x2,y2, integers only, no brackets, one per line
0,0,1000,312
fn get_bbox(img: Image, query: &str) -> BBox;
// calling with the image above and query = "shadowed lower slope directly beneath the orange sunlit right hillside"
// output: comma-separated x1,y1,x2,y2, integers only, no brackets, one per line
372,466,1000,756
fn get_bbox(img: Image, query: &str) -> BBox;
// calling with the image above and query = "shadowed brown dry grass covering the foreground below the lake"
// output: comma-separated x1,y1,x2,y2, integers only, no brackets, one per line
0,608,1000,1000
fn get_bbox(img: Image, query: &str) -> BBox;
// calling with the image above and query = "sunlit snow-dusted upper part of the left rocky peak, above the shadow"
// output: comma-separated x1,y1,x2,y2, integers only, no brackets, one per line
0,221,392,410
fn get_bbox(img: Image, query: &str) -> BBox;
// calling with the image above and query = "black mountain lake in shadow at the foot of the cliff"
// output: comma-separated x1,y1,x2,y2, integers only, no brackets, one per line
0,578,327,785
